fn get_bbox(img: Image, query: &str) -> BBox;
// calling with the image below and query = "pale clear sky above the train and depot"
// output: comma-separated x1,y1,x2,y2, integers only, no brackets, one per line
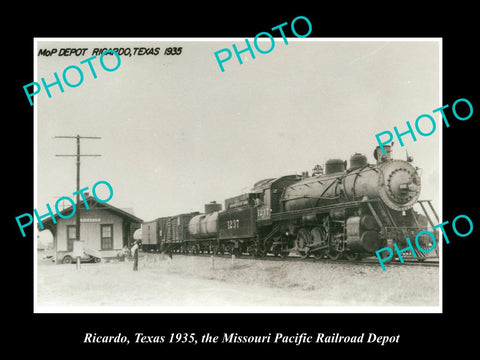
33,38,443,242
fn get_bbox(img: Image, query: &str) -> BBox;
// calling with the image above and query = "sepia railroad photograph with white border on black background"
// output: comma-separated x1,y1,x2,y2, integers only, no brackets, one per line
29,37,440,313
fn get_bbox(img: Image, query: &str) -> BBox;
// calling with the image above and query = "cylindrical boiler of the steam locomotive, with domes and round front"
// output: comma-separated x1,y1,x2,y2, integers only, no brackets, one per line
282,148,421,211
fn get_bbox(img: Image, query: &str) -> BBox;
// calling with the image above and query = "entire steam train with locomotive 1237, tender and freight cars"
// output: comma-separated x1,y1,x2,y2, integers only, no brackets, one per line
142,145,438,260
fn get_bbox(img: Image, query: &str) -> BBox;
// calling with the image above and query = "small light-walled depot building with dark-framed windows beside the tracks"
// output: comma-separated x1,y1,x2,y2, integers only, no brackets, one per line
38,193,143,264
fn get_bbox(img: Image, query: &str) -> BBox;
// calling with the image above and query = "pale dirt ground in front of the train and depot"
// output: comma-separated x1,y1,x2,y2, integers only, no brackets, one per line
37,253,439,312
